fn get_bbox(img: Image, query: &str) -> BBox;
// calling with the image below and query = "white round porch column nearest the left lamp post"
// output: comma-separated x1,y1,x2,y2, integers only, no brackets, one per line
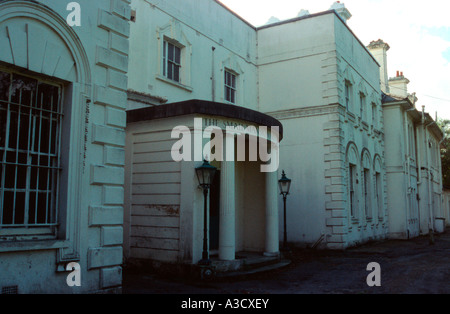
219,160,236,261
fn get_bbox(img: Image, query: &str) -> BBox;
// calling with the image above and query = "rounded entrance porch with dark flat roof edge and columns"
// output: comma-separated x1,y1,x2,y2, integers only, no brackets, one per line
124,100,282,270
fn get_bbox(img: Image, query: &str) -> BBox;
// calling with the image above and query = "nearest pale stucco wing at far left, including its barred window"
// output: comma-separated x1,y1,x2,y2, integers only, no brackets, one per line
0,0,131,293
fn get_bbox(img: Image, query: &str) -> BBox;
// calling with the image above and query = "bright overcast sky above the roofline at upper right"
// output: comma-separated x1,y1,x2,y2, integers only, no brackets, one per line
220,0,450,119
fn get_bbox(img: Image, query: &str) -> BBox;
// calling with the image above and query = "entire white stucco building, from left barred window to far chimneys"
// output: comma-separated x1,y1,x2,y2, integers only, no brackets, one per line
0,0,448,293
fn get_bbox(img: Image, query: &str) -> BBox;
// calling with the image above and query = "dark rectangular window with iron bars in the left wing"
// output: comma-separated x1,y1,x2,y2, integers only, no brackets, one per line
0,69,63,238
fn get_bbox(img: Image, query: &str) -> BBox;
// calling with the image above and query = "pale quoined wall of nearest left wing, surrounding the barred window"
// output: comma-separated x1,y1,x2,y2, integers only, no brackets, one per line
0,0,131,293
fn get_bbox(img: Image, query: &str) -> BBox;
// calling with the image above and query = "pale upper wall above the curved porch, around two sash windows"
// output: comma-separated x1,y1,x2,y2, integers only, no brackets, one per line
129,0,257,109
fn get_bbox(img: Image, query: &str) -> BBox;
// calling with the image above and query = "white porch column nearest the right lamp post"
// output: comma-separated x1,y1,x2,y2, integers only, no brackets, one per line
264,171,280,256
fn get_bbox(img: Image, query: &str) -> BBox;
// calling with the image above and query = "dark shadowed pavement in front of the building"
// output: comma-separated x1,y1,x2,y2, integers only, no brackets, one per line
123,229,450,294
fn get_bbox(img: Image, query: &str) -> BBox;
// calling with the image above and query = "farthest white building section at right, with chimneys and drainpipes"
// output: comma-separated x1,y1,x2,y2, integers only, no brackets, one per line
368,40,445,239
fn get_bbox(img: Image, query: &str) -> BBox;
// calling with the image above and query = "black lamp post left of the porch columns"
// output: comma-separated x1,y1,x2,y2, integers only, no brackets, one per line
195,160,217,265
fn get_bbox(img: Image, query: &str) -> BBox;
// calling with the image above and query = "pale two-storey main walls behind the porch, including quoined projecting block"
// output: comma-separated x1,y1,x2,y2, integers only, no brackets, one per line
126,0,387,254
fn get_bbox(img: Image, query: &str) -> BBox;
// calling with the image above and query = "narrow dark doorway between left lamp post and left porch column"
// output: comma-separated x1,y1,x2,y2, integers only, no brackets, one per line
209,170,220,250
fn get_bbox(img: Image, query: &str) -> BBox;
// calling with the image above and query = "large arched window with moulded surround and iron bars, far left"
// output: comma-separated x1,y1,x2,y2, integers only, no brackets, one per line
0,1,91,249
